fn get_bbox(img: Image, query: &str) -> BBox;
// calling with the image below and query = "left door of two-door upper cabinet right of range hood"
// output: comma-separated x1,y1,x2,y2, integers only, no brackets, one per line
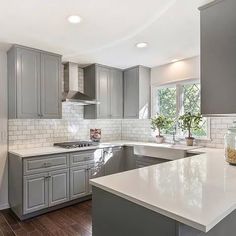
96,66,111,119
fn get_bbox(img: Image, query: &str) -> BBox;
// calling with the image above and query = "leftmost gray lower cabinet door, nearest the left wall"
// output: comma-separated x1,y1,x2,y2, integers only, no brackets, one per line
23,173,48,214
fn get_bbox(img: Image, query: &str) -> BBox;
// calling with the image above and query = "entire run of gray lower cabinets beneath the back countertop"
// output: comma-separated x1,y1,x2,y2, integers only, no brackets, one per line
9,147,166,219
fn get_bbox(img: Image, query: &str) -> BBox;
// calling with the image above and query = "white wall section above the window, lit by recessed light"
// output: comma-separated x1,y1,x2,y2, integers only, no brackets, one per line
151,56,200,85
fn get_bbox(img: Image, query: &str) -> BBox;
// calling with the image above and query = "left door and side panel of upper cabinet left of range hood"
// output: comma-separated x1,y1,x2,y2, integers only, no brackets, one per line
8,48,40,119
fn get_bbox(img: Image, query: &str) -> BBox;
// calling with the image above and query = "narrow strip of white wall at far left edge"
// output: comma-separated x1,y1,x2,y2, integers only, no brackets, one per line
0,50,8,209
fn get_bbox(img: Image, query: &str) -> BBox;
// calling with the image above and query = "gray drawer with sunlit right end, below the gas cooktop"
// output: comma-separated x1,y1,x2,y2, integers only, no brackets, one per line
70,149,103,167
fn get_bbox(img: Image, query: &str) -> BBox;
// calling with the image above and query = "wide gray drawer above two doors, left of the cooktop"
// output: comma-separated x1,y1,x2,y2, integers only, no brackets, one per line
24,154,69,175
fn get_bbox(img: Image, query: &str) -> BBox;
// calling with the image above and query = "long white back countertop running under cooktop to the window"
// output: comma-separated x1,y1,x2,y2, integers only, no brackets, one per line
9,140,201,158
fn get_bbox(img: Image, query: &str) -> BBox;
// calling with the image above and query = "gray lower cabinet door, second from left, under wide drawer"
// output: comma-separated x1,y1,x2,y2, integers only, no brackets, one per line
48,169,69,206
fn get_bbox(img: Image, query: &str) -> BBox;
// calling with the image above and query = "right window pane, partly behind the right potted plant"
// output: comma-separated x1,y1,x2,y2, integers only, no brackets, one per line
183,83,207,136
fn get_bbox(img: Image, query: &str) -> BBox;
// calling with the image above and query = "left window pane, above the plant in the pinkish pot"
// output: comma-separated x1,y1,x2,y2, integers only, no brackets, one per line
157,87,176,118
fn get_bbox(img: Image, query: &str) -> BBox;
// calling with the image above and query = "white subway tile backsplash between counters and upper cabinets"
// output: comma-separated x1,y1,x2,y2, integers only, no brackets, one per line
8,69,236,150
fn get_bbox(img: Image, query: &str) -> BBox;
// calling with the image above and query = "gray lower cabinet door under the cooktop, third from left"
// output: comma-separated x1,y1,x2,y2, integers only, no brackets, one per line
70,165,88,199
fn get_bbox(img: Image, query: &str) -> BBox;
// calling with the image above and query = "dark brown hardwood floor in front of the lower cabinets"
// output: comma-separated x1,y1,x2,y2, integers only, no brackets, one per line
0,201,92,236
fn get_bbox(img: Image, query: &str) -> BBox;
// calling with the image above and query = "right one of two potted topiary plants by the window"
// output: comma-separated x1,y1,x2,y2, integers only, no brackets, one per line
178,112,202,146
